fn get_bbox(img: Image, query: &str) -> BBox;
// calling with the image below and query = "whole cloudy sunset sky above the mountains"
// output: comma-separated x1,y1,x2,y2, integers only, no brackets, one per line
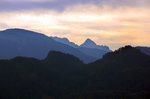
0,0,150,50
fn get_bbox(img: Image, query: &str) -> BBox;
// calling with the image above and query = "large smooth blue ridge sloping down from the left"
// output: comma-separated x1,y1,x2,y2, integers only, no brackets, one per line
0,29,96,63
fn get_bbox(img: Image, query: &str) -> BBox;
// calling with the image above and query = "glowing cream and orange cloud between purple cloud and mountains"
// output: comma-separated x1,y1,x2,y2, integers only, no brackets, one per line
0,4,150,49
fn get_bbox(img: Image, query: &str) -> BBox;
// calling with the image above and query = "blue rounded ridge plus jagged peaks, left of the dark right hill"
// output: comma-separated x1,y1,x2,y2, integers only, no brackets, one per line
0,29,110,63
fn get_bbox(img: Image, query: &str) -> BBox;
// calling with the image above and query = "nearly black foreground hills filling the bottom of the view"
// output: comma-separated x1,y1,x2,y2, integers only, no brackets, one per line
0,46,150,99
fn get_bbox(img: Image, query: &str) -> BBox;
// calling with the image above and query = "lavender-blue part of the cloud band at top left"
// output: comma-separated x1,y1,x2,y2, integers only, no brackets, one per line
0,0,101,12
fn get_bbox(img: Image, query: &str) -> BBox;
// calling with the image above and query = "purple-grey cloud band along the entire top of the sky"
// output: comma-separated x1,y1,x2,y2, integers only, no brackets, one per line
0,0,150,12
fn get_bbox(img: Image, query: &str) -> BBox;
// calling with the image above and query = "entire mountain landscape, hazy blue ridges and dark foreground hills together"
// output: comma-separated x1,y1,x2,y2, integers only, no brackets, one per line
0,29,150,99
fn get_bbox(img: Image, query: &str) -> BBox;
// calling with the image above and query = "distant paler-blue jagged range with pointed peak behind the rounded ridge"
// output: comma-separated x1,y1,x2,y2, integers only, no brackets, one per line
50,37,111,59
